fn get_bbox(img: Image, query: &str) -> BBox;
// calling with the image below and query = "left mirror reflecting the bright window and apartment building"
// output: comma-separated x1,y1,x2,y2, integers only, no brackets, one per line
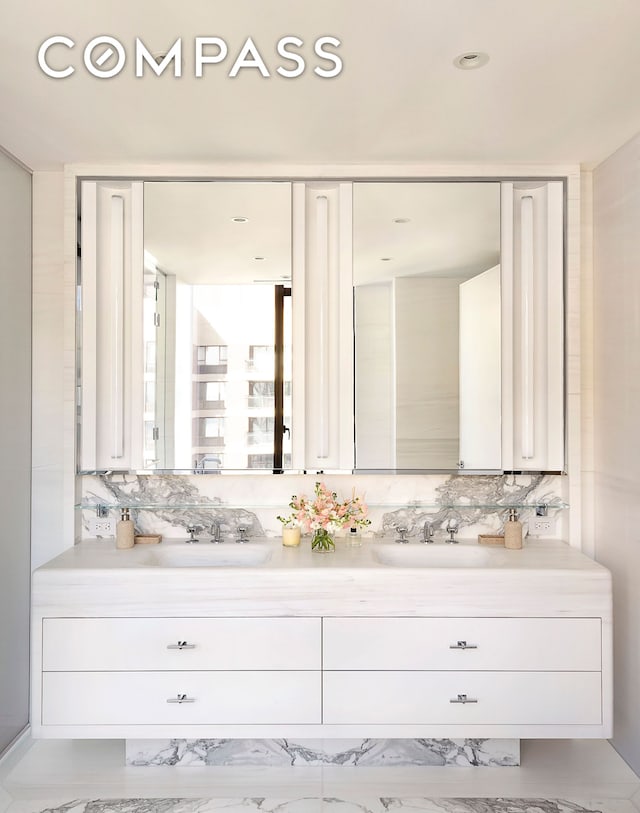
143,182,291,473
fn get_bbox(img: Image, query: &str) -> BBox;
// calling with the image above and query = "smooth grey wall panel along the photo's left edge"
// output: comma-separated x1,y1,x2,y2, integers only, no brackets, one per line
0,151,31,753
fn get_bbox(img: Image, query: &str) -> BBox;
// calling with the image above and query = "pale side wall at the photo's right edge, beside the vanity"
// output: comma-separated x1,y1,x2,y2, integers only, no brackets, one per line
593,136,640,772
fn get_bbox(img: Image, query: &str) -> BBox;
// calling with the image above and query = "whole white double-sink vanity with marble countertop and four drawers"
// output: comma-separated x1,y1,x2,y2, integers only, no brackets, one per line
32,539,612,738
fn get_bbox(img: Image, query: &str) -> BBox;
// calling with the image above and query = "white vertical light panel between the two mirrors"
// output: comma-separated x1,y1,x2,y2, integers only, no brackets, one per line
292,181,354,471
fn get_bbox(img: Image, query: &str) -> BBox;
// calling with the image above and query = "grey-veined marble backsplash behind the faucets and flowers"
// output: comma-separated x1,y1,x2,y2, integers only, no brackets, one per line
77,474,567,541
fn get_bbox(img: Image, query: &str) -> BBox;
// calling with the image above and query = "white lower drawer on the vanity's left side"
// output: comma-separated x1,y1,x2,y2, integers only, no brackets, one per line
42,671,321,725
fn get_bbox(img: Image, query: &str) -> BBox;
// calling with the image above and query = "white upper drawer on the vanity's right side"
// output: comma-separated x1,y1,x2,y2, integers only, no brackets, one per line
323,618,602,671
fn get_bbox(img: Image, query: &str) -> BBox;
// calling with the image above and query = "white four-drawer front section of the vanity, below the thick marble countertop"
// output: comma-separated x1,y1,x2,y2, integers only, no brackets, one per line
34,617,604,737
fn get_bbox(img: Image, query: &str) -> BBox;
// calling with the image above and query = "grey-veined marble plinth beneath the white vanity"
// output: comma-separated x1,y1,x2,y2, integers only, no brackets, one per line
125,739,520,768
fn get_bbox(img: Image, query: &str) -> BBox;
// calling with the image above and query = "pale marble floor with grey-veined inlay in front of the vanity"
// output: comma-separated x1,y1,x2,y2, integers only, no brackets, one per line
0,740,640,813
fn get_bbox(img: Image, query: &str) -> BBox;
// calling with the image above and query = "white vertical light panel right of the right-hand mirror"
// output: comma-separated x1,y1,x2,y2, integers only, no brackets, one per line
500,181,565,471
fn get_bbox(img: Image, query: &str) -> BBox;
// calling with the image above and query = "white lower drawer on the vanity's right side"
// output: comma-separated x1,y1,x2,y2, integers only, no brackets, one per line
323,672,602,726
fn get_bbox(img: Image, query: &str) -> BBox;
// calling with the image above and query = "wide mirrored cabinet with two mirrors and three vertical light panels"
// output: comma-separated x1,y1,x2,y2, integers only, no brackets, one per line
77,174,564,474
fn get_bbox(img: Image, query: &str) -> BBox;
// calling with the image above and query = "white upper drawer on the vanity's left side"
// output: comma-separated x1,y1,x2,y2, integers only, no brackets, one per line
42,618,321,672
